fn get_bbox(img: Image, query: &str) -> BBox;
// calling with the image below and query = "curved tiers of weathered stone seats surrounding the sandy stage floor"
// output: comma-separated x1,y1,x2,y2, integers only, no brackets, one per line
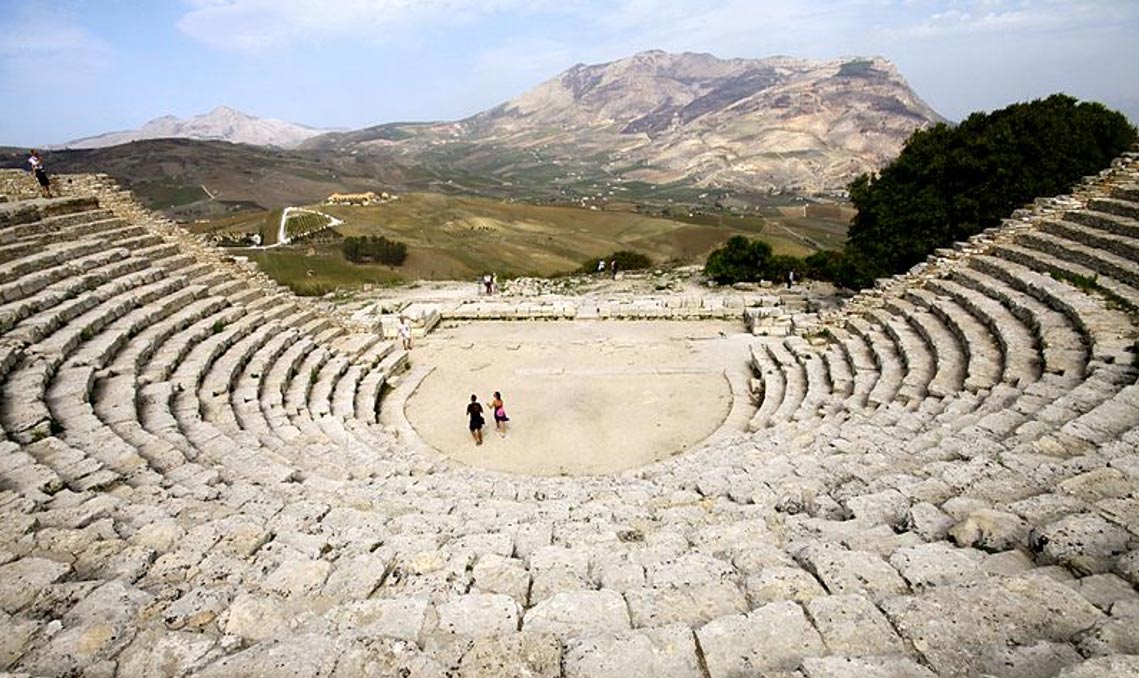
0,154,1139,678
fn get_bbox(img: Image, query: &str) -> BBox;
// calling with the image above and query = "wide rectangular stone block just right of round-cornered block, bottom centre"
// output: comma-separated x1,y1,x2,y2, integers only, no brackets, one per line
625,581,748,628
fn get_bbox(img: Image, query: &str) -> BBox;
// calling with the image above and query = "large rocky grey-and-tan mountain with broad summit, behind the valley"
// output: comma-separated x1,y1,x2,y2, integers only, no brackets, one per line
302,51,943,191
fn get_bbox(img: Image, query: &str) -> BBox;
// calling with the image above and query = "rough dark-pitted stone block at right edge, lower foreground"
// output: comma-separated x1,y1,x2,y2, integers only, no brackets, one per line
1031,513,1132,573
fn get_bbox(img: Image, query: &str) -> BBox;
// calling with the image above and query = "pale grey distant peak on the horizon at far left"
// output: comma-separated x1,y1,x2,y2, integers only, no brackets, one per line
60,106,329,148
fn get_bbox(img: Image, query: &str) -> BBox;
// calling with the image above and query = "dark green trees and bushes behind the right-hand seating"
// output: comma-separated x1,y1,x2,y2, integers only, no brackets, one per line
705,95,1137,289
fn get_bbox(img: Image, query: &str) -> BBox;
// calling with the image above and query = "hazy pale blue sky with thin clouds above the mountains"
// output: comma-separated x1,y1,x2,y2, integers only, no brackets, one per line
0,0,1139,146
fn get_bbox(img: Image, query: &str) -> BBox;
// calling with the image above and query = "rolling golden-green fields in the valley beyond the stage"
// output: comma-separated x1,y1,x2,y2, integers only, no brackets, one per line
200,193,846,292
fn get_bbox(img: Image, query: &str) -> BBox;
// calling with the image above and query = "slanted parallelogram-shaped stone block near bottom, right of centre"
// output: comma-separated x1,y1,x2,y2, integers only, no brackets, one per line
806,594,906,656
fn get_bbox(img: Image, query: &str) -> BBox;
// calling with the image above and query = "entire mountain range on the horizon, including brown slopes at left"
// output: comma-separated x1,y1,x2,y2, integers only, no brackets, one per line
26,51,943,207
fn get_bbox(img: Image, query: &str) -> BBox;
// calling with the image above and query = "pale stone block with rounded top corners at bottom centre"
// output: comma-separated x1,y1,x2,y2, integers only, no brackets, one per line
523,589,631,638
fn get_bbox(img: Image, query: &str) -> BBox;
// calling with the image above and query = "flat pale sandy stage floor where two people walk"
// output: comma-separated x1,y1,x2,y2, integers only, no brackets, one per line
404,321,749,475
